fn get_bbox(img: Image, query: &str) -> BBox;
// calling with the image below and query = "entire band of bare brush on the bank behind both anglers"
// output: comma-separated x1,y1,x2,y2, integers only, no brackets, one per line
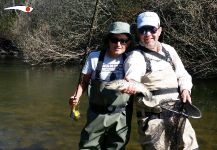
0,0,217,78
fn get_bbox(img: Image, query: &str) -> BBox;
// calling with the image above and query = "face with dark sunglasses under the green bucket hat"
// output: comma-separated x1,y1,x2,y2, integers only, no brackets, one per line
108,34,130,57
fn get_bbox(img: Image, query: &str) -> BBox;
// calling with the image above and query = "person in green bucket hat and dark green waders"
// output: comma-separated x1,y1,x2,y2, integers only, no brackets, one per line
69,22,132,150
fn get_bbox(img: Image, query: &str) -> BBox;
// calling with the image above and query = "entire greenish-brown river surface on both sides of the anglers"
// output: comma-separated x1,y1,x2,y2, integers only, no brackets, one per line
0,60,217,150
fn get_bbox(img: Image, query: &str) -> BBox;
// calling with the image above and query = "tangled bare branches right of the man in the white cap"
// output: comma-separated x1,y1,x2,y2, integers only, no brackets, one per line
155,0,217,78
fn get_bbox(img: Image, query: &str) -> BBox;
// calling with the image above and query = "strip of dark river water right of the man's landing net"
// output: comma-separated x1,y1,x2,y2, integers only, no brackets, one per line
192,80,217,150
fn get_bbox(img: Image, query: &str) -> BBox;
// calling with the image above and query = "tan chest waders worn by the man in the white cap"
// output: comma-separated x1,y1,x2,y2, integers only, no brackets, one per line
137,47,198,150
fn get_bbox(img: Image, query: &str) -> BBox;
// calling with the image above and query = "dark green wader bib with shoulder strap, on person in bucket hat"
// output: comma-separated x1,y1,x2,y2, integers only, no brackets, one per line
88,51,130,114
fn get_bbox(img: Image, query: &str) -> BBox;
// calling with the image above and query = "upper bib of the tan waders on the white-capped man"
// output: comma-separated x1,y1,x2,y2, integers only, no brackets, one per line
137,46,179,113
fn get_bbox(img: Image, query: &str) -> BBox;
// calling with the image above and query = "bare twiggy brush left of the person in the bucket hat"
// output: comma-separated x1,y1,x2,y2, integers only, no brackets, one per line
8,0,114,65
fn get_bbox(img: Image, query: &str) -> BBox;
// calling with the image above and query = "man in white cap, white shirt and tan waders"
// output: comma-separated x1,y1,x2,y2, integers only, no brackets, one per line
124,11,198,150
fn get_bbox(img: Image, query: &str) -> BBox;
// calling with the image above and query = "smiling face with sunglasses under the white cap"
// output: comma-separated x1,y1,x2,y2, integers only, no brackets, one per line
139,26,162,51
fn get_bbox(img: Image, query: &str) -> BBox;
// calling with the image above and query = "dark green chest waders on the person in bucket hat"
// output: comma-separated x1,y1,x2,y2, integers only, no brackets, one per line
79,51,133,150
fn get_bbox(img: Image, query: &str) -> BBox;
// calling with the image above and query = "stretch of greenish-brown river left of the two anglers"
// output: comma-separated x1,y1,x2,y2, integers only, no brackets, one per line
0,59,84,149
